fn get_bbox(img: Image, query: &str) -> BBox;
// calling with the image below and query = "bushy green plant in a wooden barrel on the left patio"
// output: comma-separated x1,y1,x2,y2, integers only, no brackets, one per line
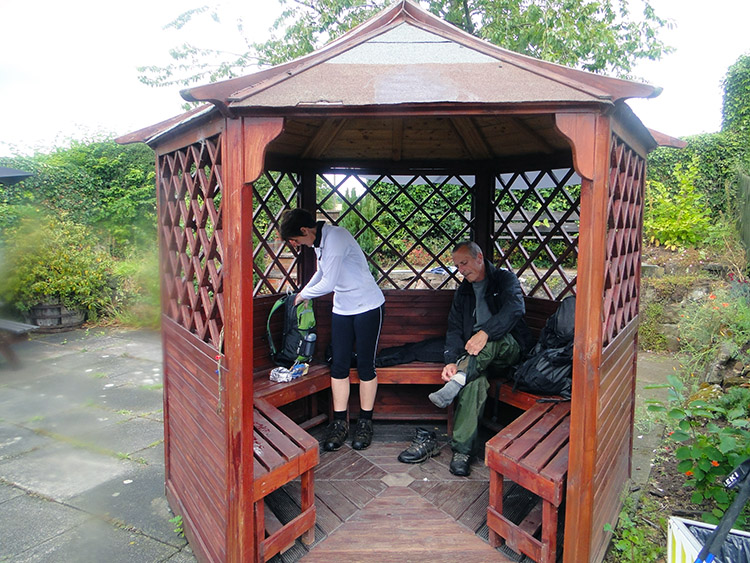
0,217,111,329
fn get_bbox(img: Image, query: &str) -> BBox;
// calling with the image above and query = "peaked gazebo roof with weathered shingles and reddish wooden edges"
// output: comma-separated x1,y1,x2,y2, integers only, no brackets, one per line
182,0,660,113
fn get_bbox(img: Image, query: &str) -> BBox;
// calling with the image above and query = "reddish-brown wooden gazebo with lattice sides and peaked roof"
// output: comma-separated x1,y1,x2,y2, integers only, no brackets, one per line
120,0,680,563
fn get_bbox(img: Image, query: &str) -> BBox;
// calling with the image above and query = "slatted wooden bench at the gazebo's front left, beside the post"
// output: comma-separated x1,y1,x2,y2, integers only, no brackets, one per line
253,399,319,563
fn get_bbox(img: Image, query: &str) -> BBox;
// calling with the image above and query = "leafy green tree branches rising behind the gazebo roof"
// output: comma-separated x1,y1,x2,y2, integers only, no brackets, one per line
139,0,671,86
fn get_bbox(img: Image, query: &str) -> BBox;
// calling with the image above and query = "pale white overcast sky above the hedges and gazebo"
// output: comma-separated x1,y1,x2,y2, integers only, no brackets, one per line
0,0,750,156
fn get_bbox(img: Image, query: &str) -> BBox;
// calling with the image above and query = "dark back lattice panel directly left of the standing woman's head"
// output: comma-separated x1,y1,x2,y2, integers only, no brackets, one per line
253,172,300,295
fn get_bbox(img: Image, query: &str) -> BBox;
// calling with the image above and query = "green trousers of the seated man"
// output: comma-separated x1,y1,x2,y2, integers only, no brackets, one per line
451,334,521,455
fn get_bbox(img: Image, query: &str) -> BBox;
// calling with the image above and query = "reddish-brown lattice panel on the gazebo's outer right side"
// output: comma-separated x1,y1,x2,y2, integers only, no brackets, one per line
603,135,646,347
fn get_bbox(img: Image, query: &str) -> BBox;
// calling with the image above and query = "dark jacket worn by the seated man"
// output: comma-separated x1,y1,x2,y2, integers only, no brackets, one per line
444,259,532,364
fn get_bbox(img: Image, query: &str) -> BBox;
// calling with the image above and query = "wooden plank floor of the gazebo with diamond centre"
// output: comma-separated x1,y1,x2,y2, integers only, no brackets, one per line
268,421,533,563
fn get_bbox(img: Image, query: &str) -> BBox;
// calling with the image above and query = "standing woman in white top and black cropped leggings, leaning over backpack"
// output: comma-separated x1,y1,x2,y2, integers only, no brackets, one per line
280,209,385,451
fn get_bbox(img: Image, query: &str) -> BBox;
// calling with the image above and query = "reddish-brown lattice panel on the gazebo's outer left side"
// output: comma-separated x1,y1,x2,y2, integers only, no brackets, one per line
159,136,224,350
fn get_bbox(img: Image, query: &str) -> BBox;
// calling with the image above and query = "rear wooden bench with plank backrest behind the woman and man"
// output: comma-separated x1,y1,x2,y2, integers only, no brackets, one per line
253,290,557,426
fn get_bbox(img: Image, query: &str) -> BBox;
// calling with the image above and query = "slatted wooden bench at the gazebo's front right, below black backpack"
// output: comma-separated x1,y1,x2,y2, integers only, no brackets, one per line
485,402,570,563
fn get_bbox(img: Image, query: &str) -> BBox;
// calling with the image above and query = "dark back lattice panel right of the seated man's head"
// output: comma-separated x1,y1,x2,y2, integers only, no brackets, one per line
491,169,580,300
